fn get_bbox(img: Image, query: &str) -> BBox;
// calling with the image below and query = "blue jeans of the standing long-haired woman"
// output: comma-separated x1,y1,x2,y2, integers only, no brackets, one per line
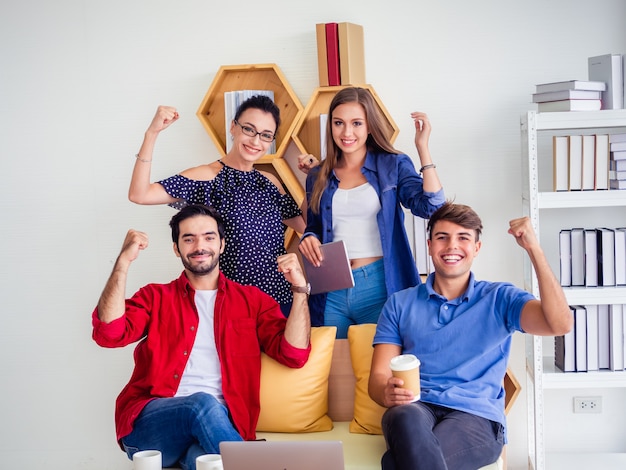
324,259,387,338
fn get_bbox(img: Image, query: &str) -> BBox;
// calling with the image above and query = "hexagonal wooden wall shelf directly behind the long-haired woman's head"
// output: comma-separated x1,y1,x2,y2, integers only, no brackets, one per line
293,85,400,157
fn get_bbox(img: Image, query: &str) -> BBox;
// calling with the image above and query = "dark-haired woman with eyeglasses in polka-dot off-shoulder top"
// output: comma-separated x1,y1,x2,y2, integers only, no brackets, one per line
128,95,305,315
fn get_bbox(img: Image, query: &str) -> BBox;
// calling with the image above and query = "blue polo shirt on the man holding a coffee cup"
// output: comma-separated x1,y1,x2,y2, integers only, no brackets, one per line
374,273,534,426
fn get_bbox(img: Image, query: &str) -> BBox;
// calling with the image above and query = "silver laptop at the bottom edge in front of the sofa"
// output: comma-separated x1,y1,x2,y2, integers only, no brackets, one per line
220,441,344,470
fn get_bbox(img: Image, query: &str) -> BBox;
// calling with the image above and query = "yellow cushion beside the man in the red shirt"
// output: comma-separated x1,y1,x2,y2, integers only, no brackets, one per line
256,326,337,432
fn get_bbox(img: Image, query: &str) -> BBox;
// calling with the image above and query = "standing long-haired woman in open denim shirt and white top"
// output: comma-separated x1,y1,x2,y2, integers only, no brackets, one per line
299,87,445,338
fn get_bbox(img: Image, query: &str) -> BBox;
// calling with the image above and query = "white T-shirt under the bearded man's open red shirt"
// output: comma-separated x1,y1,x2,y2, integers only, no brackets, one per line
174,290,224,403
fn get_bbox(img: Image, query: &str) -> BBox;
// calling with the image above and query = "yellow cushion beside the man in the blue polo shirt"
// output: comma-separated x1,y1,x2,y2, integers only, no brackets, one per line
348,323,386,434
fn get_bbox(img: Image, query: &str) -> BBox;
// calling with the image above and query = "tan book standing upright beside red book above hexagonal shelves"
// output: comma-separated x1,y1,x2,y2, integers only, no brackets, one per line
337,23,367,85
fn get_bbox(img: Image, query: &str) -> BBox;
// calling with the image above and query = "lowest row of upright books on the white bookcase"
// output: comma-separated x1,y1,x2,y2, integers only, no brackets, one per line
554,304,626,372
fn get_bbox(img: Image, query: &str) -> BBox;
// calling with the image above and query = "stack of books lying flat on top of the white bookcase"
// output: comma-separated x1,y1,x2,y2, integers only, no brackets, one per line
533,80,606,113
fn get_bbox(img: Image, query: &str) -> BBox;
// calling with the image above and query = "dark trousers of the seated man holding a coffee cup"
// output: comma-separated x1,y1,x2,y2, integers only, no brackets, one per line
382,401,504,470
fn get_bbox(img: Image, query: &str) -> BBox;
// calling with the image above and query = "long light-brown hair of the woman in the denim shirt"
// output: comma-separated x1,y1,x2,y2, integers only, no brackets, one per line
309,87,400,214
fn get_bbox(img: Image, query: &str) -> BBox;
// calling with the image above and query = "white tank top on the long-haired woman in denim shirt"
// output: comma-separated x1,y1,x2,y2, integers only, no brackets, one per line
333,183,383,259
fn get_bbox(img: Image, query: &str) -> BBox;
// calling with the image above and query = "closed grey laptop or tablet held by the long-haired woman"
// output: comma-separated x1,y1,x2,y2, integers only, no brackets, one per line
302,241,354,294
